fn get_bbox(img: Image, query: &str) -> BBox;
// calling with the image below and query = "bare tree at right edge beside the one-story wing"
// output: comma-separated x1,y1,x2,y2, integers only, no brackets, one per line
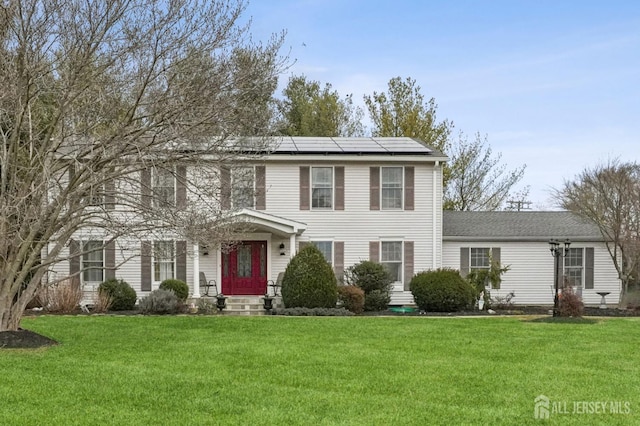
554,160,640,302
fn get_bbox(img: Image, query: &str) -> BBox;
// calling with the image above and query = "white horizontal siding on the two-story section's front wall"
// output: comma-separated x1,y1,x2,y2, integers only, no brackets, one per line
52,155,442,305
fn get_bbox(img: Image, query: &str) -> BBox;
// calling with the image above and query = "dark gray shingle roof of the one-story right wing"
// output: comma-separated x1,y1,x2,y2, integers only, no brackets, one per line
442,210,602,241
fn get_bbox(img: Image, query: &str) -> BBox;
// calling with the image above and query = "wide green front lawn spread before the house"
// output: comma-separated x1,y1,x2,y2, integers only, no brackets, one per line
0,316,640,425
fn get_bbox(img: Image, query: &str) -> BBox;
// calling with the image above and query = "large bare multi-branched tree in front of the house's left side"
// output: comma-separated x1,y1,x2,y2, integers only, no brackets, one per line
0,0,286,331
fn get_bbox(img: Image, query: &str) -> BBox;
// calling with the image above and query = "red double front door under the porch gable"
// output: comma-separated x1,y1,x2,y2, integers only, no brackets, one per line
222,241,267,296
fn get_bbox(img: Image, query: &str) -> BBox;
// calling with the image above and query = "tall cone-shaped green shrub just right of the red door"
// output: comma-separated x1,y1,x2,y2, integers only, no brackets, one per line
281,244,338,308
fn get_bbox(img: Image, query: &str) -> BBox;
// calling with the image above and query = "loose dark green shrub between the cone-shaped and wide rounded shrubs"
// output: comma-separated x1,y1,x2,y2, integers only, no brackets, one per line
344,260,393,311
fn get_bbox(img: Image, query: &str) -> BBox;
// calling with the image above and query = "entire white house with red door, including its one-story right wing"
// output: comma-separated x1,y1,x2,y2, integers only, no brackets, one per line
57,137,620,305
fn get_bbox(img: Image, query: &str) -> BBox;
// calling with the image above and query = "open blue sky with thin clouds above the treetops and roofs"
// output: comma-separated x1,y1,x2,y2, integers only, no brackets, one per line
246,0,640,209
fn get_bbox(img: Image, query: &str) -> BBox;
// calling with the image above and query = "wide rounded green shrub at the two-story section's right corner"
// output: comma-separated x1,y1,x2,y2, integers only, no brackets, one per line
410,268,476,312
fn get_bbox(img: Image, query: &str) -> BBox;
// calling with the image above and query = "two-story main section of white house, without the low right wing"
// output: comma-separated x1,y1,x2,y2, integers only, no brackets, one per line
59,137,447,304
